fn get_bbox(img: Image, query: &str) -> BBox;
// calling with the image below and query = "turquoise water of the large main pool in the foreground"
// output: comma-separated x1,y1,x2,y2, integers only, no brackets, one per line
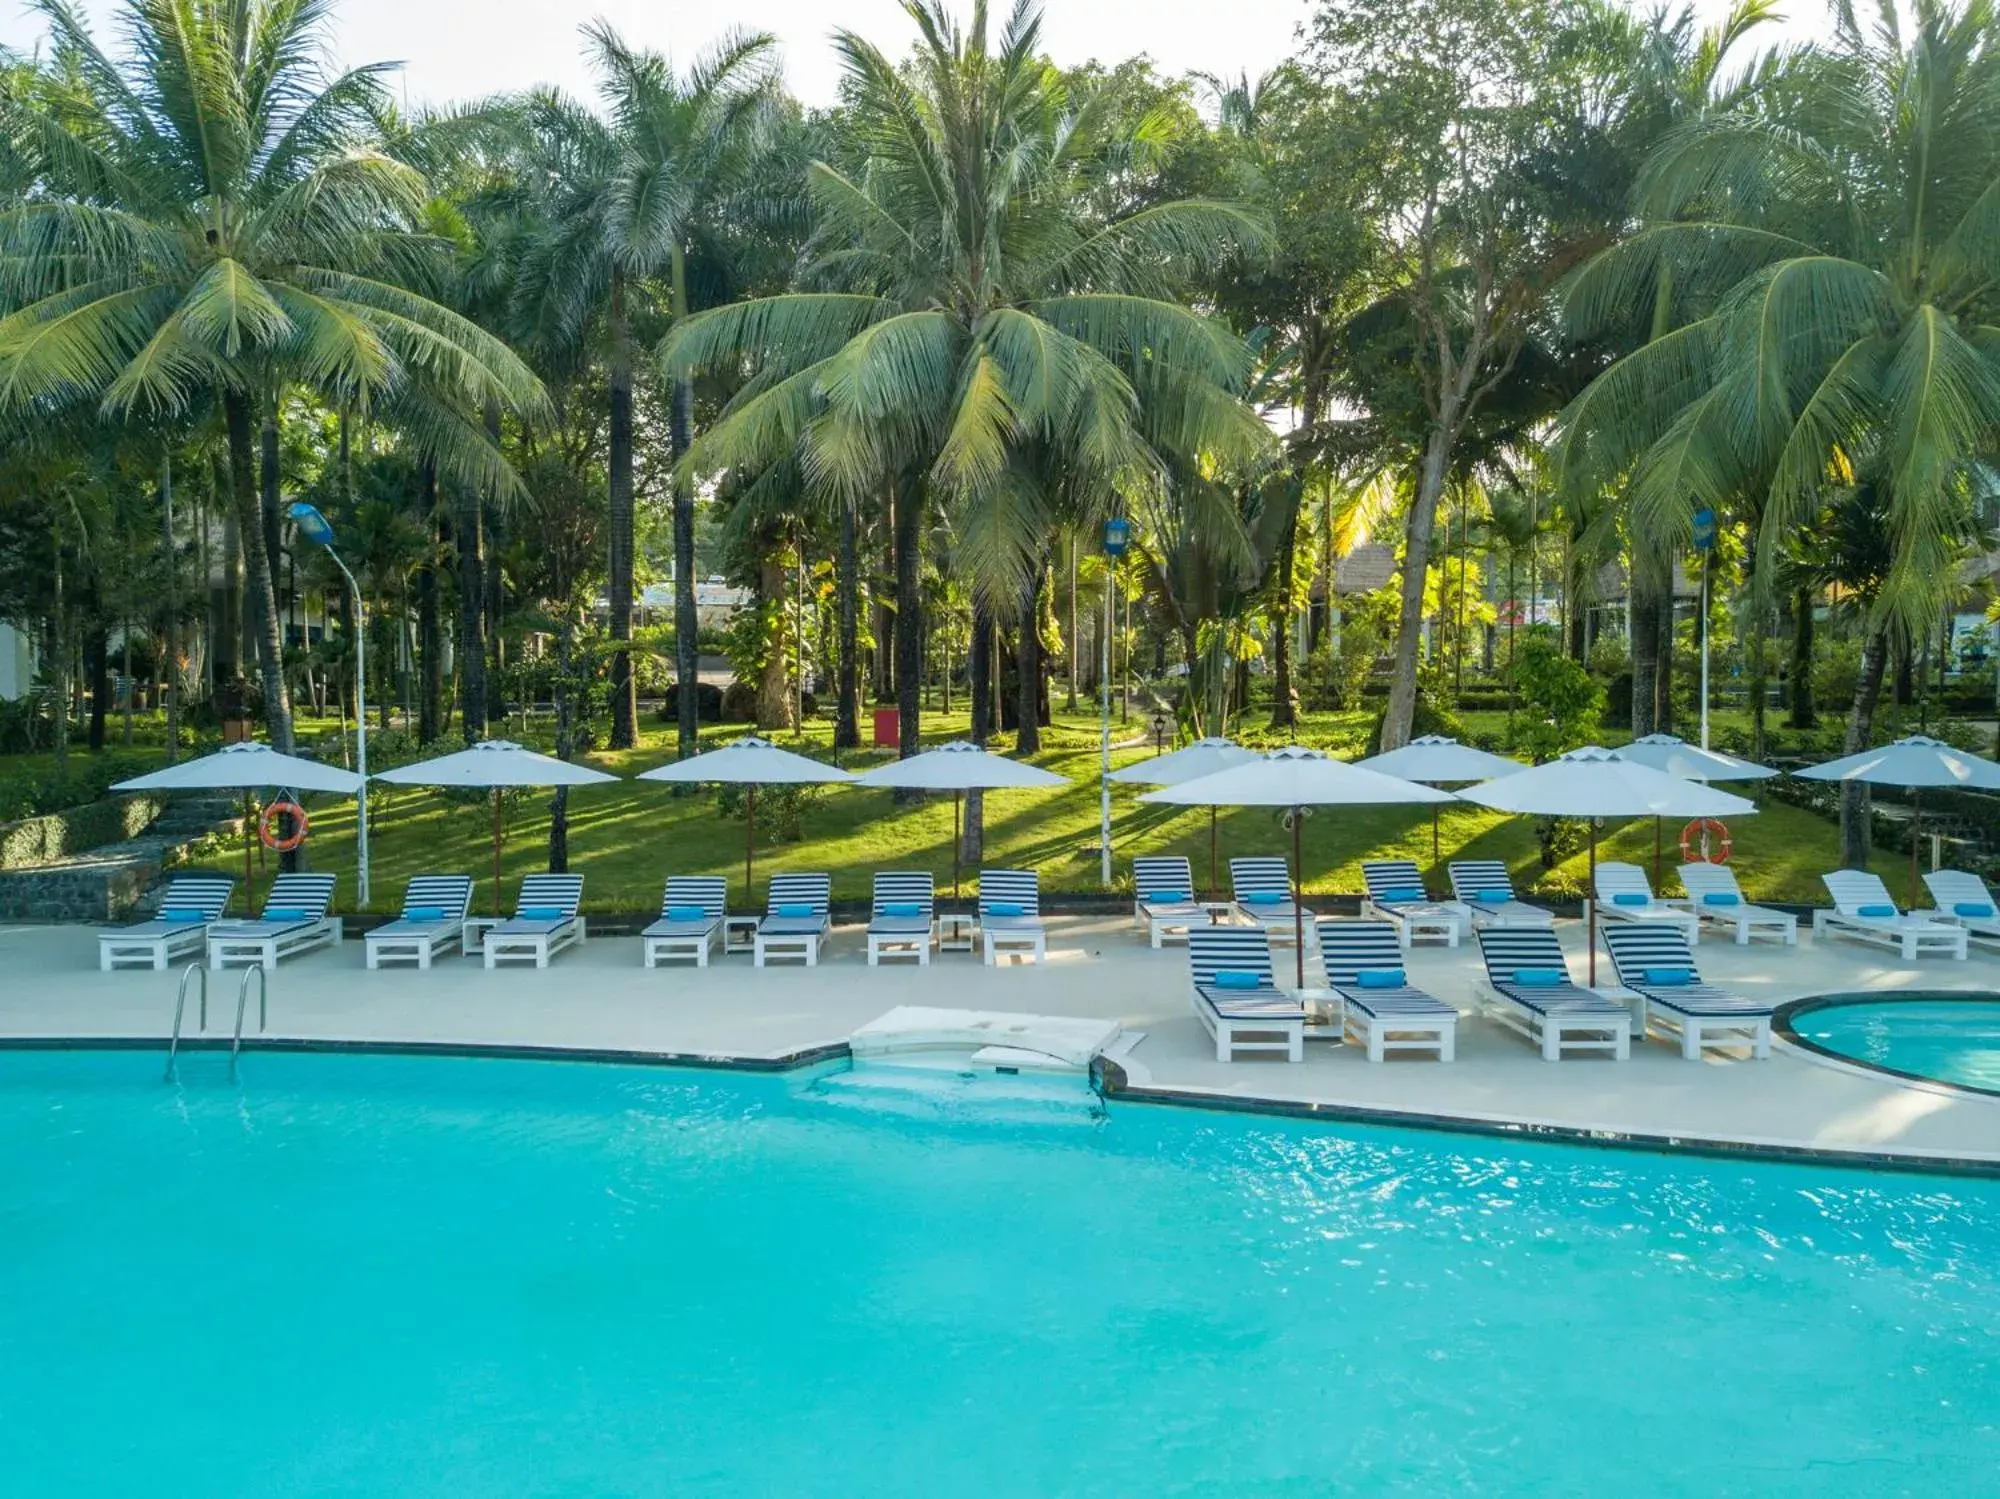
0,1051,2000,1499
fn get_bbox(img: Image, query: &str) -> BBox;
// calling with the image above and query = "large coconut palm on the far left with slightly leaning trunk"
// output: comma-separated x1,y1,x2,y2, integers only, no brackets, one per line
0,0,540,750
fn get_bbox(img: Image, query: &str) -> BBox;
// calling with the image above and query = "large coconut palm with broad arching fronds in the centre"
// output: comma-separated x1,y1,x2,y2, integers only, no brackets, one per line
660,0,1266,753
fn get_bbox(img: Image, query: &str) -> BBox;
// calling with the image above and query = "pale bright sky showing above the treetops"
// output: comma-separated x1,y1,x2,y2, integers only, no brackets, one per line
0,0,1824,114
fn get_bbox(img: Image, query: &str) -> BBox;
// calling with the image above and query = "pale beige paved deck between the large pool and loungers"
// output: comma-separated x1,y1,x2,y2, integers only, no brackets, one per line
0,917,2000,1169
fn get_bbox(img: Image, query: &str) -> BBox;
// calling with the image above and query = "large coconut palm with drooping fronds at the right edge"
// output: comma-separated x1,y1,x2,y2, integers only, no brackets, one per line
1564,0,2000,861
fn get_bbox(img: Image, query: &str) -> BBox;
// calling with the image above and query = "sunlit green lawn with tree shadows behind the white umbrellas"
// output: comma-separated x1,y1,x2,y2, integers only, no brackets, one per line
160,714,1902,911
